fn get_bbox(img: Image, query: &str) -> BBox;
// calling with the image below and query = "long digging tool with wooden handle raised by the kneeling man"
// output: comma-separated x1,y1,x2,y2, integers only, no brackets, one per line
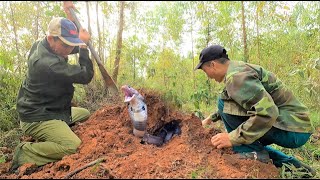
69,8,119,95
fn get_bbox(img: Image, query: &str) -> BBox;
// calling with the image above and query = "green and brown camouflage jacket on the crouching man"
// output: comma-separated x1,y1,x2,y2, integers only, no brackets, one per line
220,61,314,145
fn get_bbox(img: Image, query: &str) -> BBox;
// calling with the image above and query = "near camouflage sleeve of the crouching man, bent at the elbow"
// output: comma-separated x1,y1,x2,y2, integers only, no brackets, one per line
226,69,279,145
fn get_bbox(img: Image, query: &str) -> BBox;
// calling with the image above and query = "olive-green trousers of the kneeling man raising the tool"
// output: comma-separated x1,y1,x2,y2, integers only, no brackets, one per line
15,107,90,166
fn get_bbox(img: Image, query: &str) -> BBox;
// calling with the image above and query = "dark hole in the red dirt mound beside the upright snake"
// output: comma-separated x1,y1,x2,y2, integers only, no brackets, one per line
140,120,181,147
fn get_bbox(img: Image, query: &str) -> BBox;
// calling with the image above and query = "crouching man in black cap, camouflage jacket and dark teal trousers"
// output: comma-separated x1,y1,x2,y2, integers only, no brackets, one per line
195,45,316,177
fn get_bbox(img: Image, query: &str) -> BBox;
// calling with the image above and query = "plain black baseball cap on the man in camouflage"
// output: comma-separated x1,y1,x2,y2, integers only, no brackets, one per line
194,45,229,70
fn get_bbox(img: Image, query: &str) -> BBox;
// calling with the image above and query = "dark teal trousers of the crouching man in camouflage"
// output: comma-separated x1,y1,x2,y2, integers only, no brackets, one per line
218,99,311,168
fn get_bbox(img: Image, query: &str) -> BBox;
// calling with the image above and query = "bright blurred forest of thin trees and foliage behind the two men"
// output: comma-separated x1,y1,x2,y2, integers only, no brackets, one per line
0,1,320,176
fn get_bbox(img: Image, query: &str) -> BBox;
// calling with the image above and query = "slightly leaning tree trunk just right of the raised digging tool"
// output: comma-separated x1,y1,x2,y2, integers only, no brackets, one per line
112,1,125,83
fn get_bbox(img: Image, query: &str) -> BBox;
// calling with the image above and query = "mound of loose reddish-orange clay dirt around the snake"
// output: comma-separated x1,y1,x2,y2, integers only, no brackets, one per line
0,89,279,179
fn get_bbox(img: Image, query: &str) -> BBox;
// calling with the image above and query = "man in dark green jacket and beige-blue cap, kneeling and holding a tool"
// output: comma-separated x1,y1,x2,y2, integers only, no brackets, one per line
10,2,94,172
